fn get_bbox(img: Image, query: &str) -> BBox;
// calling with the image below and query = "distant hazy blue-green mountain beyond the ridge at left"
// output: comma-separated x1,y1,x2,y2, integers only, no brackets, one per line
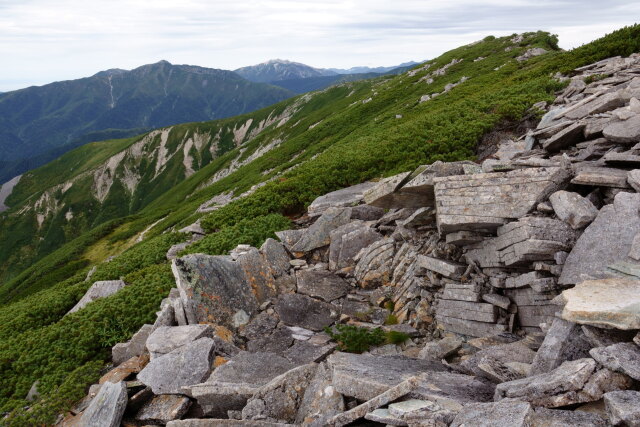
0,61,292,182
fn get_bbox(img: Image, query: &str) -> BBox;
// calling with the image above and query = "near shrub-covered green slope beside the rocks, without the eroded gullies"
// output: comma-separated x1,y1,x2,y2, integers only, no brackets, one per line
0,26,640,425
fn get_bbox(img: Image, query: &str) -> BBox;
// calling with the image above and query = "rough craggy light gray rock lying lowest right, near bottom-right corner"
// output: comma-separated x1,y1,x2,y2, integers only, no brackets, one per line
494,359,632,408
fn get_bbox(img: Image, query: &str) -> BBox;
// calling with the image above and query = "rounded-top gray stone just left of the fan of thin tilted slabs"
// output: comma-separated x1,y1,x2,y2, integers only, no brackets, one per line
329,221,382,271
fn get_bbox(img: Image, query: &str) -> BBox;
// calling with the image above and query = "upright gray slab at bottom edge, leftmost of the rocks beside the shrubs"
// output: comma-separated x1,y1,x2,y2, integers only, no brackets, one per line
76,381,127,427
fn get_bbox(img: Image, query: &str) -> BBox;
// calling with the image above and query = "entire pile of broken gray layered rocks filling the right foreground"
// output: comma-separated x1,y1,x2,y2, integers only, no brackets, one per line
58,55,640,427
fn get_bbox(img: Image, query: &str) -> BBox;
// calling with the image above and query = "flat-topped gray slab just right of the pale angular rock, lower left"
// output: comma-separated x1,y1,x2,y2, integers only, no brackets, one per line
185,352,295,417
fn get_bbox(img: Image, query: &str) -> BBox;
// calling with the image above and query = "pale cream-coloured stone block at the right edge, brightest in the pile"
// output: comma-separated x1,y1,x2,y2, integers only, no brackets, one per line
562,279,640,330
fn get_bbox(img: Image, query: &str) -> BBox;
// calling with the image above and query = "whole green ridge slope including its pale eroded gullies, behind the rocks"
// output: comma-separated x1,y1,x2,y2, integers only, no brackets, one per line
0,26,640,425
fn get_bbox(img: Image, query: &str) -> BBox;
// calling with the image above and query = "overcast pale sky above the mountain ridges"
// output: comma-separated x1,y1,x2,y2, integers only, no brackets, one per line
0,0,640,91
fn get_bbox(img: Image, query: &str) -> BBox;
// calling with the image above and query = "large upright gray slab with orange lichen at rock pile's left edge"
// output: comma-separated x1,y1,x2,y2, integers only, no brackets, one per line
172,254,276,330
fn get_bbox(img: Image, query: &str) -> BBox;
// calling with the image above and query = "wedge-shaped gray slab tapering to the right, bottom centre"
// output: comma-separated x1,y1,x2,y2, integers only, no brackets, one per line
327,352,447,400
